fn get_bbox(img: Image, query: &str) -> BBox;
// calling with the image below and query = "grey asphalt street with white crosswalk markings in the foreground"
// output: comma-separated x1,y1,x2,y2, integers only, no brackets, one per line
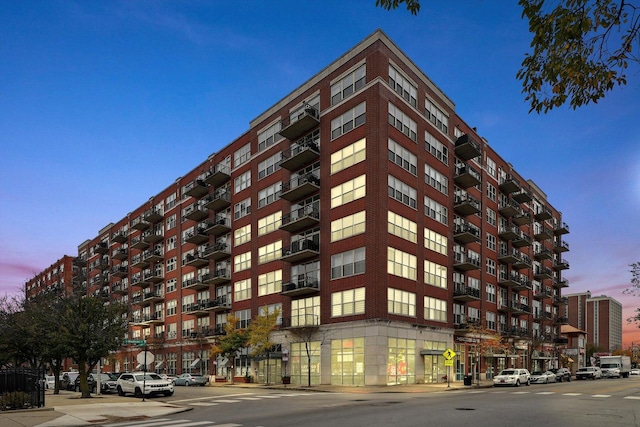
101,377,640,427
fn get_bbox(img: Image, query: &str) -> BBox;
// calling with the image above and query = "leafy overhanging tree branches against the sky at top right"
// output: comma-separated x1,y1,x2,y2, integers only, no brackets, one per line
376,0,640,113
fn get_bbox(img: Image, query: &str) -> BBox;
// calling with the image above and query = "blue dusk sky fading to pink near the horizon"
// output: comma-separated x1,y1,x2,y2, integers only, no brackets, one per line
0,0,640,346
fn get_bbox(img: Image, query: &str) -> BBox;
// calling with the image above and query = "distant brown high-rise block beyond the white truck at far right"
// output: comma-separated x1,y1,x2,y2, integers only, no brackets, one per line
563,291,622,356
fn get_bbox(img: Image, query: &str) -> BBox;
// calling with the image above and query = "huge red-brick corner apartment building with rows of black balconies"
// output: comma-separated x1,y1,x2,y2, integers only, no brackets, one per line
27,31,569,385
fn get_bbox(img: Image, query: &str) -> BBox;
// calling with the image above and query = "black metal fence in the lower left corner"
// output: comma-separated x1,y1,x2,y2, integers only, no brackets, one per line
0,368,45,411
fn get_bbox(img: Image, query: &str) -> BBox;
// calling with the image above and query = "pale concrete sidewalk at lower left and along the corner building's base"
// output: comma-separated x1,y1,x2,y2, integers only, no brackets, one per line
0,381,492,427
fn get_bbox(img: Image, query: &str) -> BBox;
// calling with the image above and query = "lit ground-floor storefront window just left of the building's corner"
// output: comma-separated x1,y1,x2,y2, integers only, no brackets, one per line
331,338,364,385
